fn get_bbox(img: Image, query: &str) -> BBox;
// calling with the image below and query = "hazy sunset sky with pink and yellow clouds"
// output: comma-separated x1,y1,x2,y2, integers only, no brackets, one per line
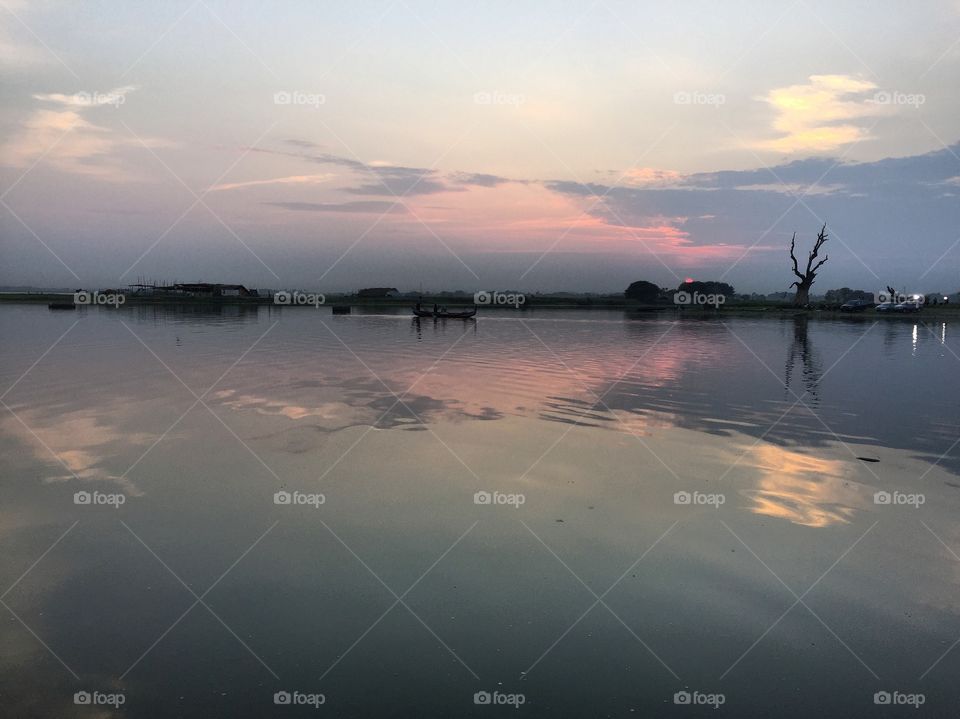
0,0,960,293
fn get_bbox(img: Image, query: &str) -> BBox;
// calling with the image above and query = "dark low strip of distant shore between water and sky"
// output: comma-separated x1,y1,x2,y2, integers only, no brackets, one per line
0,292,960,319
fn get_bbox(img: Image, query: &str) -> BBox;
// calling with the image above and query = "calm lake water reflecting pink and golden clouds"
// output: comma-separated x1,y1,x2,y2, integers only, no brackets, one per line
0,306,960,717
